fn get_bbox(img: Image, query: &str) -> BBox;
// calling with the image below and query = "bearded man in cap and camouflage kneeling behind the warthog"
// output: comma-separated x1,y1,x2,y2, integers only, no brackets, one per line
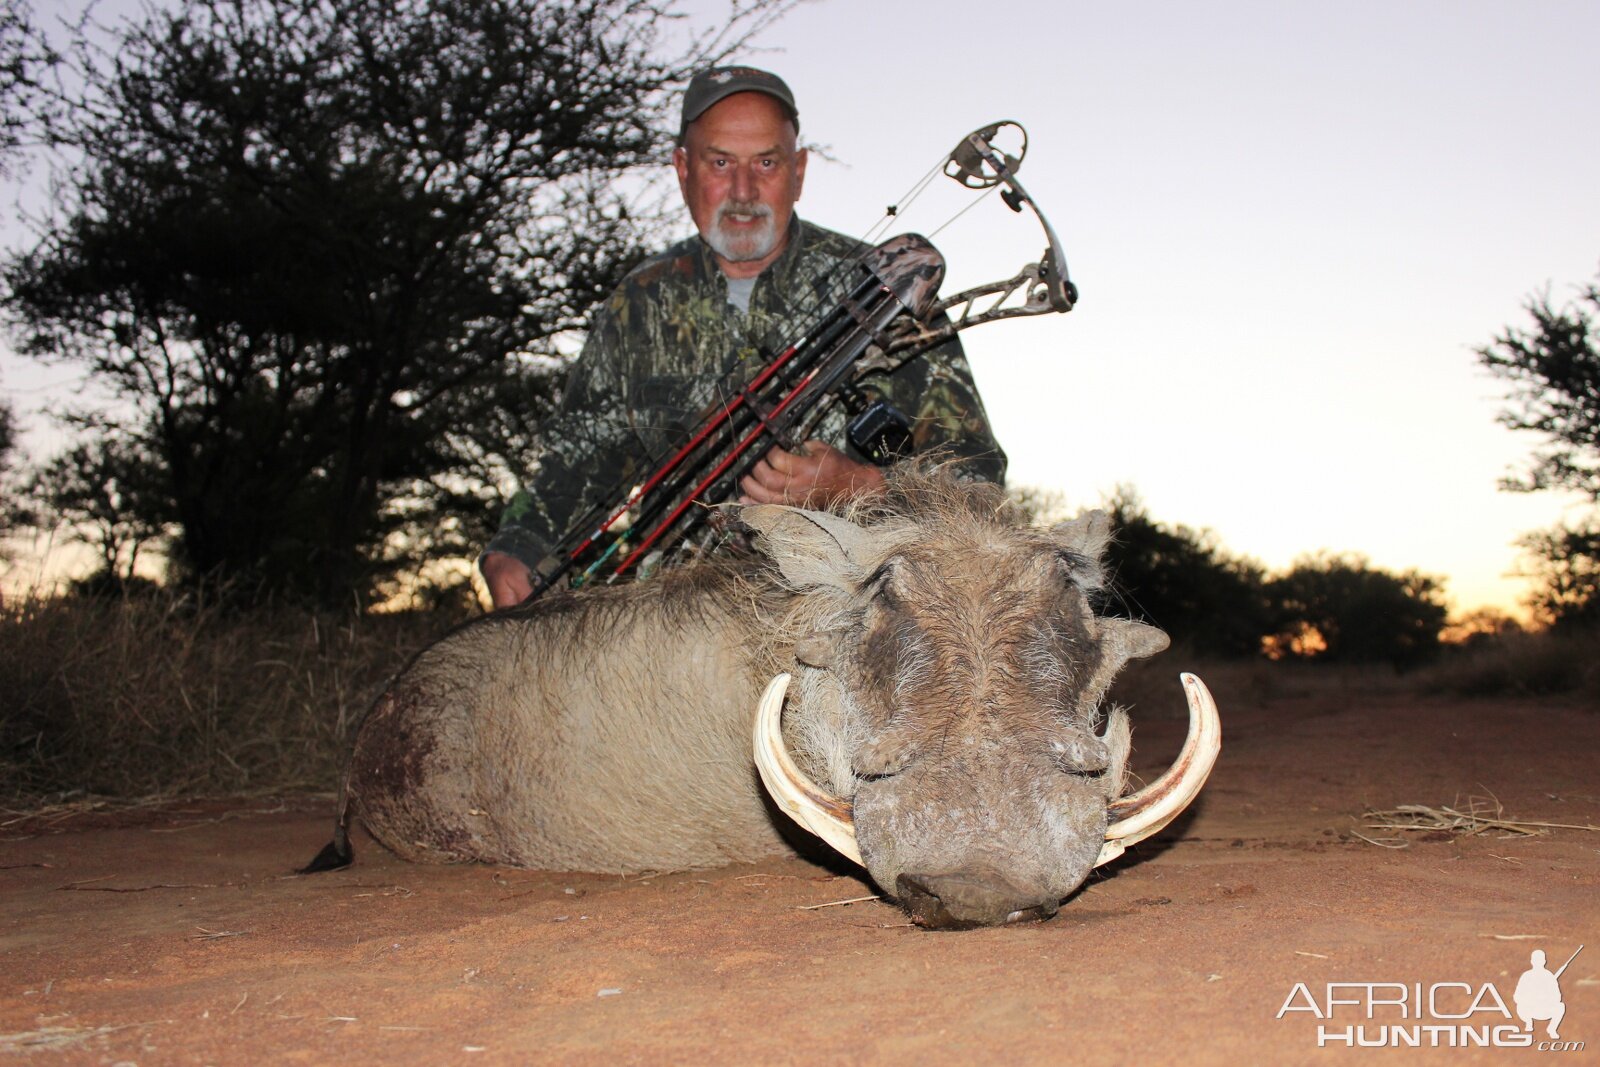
480,67,1005,608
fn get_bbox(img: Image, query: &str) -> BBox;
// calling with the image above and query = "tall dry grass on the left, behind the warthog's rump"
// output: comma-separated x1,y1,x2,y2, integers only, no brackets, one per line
0,592,467,808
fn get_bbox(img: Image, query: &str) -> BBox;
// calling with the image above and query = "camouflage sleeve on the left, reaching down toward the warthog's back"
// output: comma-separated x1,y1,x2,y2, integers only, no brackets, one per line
483,306,634,585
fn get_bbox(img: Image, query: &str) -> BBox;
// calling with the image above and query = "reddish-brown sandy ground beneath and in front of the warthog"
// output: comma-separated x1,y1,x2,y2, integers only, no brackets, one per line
0,686,1600,1065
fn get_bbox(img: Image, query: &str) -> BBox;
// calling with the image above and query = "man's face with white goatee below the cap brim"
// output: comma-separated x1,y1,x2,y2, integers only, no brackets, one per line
672,93,806,278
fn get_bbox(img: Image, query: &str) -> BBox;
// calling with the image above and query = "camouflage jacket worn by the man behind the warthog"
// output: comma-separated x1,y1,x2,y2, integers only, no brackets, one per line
485,218,1006,585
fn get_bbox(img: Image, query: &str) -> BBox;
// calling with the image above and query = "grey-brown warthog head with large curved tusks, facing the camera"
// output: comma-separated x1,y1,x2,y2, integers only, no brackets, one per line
744,478,1219,928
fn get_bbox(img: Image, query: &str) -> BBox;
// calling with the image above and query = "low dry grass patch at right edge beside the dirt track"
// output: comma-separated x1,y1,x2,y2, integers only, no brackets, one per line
1421,629,1600,705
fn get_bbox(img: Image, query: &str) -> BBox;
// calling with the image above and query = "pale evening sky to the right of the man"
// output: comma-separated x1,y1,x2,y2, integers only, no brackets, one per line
0,0,1600,609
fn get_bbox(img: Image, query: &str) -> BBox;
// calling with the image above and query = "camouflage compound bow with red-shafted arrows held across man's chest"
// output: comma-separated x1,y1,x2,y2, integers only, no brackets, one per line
530,122,1078,600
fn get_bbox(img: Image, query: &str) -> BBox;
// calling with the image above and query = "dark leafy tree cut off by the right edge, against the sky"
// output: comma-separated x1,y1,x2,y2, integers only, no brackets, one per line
1478,273,1600,624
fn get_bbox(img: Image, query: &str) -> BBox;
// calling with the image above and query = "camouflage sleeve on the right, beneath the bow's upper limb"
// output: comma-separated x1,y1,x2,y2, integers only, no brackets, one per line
864,329,1006,485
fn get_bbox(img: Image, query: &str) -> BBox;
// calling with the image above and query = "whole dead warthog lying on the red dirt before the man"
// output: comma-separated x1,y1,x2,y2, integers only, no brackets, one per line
312,469,1219,928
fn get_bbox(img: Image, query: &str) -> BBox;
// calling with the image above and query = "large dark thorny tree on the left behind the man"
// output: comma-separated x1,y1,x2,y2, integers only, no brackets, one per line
5,0,774,601
